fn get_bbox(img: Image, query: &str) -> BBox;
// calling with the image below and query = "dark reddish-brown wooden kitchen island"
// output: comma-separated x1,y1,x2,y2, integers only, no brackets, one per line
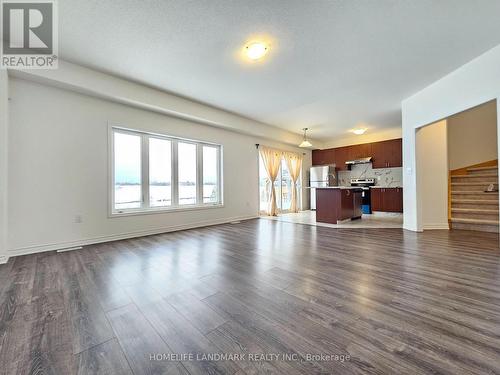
316,186,363,224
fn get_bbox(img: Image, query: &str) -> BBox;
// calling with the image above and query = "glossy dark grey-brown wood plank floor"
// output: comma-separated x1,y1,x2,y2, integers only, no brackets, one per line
0,220,500,375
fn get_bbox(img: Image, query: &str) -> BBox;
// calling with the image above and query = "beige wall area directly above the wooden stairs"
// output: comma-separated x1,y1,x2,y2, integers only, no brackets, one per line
448,101,498,170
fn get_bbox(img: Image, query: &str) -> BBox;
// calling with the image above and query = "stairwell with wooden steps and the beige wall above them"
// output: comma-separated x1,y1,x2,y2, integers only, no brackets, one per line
447,100,499,233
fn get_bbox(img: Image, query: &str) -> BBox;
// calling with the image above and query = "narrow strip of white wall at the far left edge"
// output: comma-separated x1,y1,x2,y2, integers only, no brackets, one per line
0,70,9,264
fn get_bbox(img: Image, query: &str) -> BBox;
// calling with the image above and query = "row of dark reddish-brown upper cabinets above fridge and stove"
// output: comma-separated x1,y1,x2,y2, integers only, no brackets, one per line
312,139,403,171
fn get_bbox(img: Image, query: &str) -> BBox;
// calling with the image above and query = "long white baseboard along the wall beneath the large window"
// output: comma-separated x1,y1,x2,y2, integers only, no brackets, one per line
6,215,258,263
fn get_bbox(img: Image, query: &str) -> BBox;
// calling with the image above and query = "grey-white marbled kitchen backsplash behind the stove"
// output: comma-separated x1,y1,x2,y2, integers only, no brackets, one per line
338,163,403,187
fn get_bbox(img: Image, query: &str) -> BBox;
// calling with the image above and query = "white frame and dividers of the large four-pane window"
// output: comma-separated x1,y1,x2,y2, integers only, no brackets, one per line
108,124,224,217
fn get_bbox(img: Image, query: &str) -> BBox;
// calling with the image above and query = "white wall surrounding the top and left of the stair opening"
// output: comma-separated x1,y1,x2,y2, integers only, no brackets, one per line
402,45,500,231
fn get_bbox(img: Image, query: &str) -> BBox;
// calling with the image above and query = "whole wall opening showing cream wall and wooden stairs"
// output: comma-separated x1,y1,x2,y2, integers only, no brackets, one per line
416,100,500,233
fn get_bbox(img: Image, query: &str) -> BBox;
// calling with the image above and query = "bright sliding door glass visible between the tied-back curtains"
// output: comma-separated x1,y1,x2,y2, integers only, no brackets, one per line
259,156,301,213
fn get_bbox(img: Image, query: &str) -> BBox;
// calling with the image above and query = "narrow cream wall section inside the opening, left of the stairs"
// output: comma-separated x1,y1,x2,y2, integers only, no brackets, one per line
416,120,449,230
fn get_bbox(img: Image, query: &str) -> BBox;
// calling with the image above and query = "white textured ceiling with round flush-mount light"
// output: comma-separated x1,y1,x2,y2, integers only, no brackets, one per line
58,0,500,140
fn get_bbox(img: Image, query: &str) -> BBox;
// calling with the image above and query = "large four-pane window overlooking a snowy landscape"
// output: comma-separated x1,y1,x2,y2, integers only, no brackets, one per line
111,128,222,214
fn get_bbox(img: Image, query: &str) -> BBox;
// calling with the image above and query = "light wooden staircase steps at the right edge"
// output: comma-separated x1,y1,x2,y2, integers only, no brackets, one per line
450,166,499,233
